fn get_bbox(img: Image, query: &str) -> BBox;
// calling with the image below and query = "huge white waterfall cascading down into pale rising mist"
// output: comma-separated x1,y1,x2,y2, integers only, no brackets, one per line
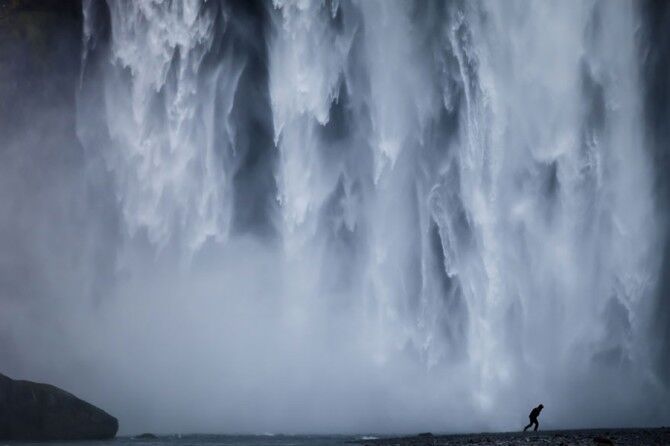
6,0,670,432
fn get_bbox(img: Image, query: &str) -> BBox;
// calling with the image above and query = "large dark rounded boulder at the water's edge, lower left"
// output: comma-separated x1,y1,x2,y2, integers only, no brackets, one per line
0,374,119,441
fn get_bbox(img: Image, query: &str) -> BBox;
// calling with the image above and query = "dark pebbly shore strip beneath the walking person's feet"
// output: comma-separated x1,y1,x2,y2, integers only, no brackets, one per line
354,427,670,446
